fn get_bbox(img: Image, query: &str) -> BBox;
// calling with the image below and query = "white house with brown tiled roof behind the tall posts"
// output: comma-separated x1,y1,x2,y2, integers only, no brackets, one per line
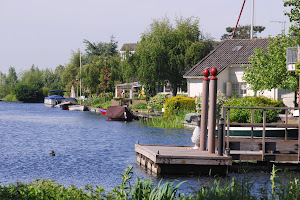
183,39,294,107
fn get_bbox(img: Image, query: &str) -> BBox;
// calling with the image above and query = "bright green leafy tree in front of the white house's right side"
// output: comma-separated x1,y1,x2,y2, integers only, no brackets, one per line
243,34,298,99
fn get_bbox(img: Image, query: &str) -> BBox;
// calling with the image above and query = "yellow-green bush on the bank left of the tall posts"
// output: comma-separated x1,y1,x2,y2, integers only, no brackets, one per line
164,96,196,116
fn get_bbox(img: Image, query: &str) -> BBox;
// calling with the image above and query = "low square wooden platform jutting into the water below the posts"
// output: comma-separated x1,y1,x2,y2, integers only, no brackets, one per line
135,144,232,175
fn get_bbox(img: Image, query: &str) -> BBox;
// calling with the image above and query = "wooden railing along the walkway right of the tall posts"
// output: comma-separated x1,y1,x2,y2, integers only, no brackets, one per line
222,106,300,162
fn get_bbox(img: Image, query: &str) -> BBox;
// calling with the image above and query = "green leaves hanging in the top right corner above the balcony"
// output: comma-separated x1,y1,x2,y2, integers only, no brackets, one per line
284,0,300,44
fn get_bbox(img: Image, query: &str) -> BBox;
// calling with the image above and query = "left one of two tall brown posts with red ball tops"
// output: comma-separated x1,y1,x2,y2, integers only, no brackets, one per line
200,69,209,151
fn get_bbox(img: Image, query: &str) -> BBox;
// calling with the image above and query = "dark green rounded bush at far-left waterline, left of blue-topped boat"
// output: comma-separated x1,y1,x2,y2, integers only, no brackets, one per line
15,83,44,103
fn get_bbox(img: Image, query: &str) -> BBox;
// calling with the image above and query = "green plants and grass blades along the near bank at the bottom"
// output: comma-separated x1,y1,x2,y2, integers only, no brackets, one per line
0,166,300,200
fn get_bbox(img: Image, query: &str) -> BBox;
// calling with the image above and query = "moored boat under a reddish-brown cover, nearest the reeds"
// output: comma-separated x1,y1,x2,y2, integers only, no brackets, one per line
105,106,138,121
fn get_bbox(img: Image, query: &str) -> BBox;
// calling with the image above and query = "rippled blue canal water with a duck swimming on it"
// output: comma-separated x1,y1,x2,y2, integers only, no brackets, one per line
0,102,292,195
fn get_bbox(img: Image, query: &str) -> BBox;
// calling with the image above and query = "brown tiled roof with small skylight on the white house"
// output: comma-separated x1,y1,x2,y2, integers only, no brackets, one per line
183,38,269,78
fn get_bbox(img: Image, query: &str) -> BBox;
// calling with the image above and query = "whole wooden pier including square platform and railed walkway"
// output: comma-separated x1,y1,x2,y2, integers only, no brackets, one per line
135,107,300,175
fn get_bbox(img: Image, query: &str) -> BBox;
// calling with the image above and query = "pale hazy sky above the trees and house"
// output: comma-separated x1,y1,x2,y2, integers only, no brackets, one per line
0,0,290,74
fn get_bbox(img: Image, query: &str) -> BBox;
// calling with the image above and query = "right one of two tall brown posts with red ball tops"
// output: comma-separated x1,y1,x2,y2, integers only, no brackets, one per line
207,67,218,153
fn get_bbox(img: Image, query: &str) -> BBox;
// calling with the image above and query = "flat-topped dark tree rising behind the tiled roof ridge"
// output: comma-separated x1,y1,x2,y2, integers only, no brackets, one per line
221,25,266,40
